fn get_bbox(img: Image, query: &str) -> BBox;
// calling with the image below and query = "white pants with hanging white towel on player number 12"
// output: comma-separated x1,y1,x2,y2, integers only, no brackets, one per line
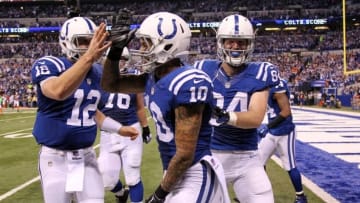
39,146,104,203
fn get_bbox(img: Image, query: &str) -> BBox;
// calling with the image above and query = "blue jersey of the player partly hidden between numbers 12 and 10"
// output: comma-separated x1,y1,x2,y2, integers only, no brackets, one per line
100,91,139,125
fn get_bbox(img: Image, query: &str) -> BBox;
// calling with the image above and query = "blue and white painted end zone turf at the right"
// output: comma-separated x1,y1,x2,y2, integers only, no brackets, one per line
293,107,360,203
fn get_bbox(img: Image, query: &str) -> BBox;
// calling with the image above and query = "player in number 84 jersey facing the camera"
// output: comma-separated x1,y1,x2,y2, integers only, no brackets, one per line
195,15,279,203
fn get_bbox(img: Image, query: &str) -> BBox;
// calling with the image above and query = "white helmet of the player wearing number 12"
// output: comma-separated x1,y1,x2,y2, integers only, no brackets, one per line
59,17,97,60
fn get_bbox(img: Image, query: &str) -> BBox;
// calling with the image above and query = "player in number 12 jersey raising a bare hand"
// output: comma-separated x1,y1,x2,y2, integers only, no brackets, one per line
31,17,138,203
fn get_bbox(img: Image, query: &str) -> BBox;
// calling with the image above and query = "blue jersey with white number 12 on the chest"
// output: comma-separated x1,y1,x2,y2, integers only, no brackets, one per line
31,56,101,150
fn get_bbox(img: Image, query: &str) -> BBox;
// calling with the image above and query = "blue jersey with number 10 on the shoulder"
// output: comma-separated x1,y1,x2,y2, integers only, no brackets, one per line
145,66,213,170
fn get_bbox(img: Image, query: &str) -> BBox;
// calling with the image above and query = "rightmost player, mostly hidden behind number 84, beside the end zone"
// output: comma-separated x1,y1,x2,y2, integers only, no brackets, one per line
258,80,307,203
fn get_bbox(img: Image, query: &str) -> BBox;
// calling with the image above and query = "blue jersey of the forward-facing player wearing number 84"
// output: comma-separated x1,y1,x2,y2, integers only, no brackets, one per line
195,60,279,150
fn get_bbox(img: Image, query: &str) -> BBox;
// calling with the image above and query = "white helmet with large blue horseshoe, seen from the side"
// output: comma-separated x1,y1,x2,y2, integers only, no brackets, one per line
130,12,191,72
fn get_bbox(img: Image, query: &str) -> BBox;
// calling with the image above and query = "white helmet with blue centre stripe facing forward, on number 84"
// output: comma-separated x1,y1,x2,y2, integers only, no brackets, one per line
216,14,255,67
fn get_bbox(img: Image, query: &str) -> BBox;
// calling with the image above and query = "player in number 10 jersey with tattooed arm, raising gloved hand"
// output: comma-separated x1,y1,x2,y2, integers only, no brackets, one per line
102,12,230,203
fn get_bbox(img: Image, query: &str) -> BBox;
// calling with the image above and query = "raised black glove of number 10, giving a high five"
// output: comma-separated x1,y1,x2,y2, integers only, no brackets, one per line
107,8,136,61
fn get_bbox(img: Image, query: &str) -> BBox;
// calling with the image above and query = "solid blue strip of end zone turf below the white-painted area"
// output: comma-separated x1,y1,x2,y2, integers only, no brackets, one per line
296,141,360,203
